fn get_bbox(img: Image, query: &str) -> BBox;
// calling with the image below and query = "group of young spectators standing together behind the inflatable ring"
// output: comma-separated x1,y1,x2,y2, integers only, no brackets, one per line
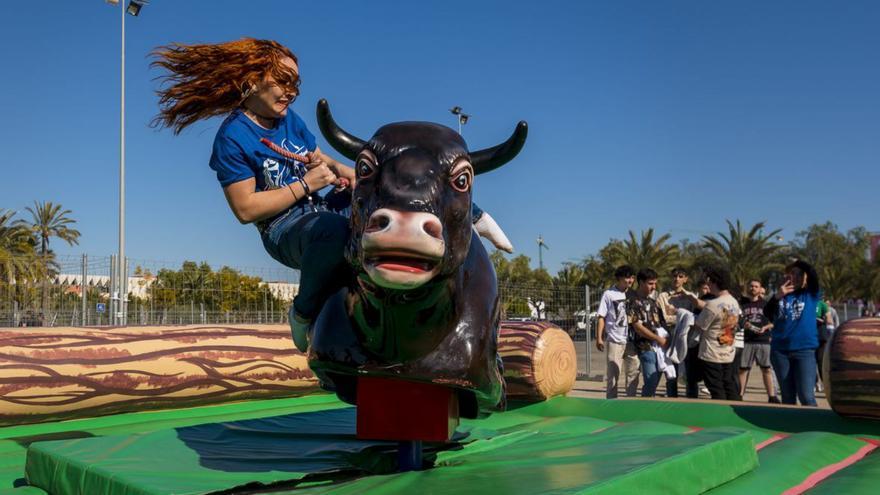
596,260,838,406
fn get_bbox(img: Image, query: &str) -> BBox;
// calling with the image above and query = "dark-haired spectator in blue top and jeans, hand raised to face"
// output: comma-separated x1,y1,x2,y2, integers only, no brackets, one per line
764,260,821,406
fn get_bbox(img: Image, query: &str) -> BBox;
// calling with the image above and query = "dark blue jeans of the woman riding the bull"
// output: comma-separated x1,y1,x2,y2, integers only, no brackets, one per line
262,206,349,320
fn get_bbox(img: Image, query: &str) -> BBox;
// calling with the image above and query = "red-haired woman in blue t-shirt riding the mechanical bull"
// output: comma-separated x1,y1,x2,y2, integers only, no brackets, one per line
152,38,513,351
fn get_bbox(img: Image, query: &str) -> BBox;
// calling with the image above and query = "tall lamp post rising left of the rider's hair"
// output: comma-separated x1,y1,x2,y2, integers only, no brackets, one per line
106,0,149,325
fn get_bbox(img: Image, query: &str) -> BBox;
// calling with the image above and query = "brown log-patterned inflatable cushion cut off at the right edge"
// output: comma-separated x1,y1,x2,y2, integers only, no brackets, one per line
822,318,880,419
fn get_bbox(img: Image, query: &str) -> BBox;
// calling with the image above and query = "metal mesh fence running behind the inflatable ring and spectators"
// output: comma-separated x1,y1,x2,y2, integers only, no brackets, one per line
6,256,876,380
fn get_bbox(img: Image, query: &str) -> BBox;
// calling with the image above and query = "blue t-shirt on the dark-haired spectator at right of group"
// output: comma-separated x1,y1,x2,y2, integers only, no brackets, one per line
770,291,819,351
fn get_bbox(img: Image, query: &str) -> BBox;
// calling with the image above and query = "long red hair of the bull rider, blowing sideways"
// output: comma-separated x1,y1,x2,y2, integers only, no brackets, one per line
150,38,299,134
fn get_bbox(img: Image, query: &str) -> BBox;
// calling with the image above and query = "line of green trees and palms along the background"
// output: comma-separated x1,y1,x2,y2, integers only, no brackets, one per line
0,201,880,314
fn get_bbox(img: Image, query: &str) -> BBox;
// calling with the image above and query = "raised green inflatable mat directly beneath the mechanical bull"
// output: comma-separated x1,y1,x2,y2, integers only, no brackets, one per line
27,409,757,495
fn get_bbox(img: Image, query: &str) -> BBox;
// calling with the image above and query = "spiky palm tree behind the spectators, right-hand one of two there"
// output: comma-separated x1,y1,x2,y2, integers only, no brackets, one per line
703,220,785,291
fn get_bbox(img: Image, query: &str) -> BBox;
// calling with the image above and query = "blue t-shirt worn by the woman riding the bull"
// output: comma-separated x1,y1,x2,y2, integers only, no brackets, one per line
210,109,315,191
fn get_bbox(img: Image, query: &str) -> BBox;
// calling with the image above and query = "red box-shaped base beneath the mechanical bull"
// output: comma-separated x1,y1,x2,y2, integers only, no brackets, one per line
357,377,458,442
